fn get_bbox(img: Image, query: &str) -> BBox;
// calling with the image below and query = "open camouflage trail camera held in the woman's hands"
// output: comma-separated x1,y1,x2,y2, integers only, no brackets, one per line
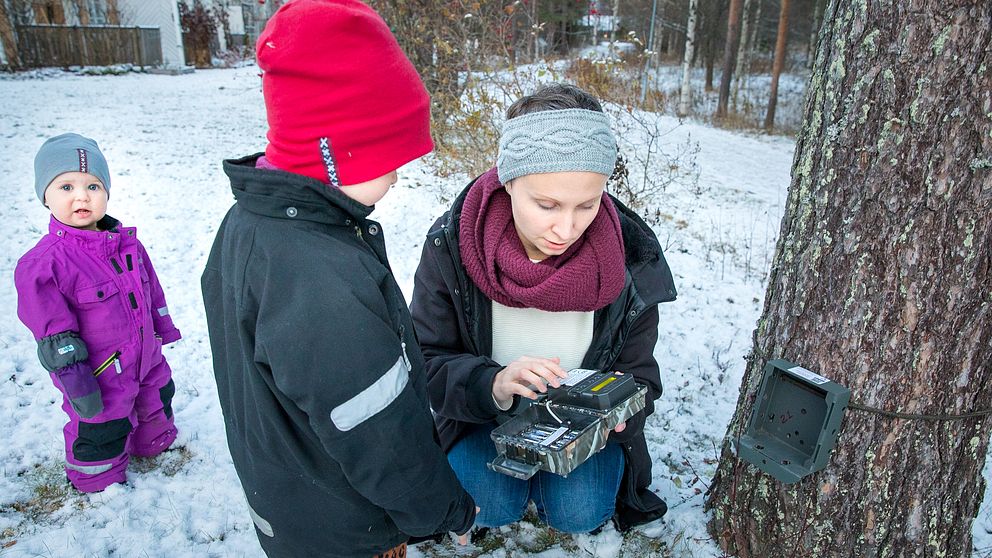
489,368,648,480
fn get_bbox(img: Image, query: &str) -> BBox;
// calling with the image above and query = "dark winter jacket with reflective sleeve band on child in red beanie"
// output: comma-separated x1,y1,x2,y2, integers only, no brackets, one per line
202,155,475,558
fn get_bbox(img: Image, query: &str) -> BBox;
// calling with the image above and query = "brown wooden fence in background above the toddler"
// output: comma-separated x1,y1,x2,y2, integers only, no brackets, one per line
15,25,162,68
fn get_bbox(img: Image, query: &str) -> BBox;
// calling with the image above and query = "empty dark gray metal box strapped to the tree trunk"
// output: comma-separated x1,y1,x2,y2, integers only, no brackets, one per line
737,359,851,483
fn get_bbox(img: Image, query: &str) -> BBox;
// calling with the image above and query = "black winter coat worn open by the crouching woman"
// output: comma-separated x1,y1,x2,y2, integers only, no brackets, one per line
411,182,676,530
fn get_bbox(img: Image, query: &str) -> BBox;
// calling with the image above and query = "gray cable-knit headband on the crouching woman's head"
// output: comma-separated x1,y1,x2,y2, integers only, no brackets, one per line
496,109,617,184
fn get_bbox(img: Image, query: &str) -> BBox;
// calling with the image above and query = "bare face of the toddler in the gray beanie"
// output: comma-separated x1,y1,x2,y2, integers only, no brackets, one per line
45,172,107,231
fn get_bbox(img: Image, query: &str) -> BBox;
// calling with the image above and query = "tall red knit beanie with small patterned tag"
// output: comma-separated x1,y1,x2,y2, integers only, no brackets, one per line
256,0,434,186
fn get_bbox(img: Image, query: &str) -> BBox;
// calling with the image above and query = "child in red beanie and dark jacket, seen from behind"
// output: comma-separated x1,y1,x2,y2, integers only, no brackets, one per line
202,0,476,558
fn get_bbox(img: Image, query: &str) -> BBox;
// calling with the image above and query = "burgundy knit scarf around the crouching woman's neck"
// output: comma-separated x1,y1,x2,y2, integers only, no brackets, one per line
458,168,626,312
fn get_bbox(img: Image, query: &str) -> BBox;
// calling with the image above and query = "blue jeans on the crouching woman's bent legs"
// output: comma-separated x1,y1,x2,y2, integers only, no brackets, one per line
448,424,624,533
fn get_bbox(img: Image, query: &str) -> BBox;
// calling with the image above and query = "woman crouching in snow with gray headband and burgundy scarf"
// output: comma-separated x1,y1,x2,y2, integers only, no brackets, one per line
411,85,675,533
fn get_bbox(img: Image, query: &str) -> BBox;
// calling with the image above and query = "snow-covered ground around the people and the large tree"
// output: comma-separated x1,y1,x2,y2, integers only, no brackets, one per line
0,66,992,558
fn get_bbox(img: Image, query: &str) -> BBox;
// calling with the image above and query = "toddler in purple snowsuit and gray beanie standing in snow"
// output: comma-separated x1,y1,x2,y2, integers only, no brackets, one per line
14,134,180,492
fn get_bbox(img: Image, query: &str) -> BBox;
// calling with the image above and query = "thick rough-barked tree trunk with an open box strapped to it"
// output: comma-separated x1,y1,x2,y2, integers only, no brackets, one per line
707,0,992,558
